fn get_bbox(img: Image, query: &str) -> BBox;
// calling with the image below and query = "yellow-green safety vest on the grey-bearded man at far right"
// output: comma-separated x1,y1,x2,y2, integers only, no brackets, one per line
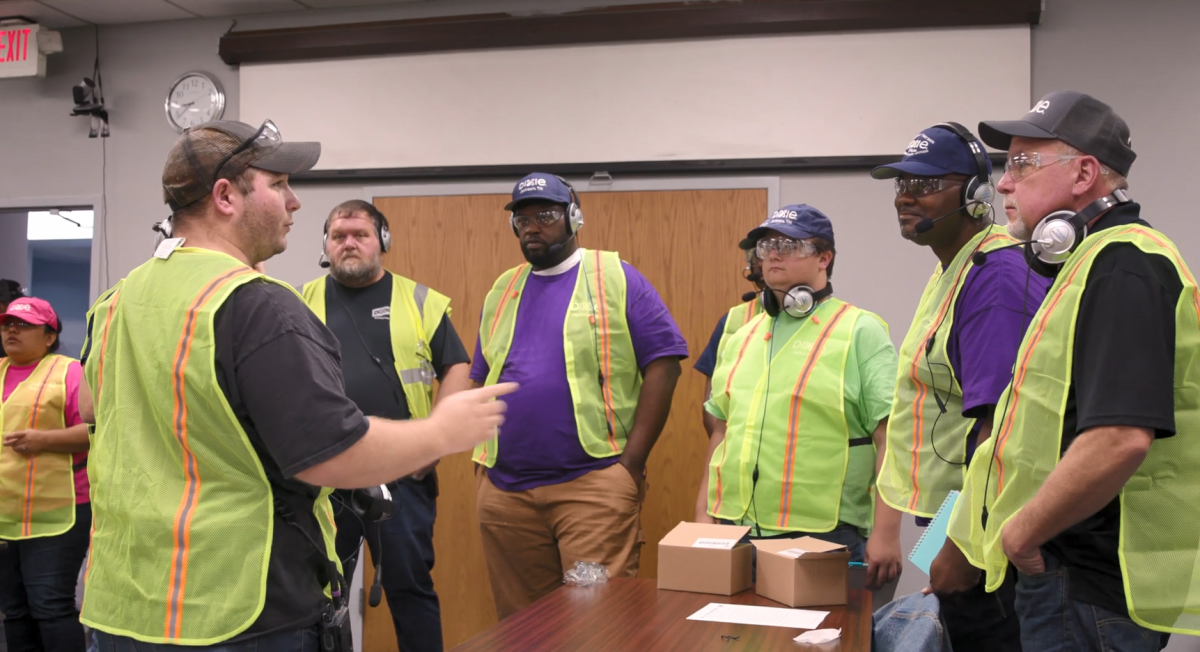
948,226,1200,635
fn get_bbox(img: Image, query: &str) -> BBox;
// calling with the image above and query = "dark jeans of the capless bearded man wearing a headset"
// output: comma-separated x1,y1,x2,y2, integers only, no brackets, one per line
334,478,443,652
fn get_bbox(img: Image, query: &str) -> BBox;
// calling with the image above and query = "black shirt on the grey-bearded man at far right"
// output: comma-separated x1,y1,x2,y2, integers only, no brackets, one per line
1044,203,1183,615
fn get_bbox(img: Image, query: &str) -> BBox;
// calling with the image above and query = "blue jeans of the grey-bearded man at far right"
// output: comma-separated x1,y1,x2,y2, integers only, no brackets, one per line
1016,552,1168,652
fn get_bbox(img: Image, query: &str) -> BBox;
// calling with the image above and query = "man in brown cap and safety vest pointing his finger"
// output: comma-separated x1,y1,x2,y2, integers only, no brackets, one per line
73,121,512,651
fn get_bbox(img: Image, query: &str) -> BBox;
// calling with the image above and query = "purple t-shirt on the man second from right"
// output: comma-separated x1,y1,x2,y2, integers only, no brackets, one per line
917,249,1050,526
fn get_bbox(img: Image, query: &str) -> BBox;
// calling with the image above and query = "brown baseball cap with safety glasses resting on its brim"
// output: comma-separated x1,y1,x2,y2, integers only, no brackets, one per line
162,120,320,213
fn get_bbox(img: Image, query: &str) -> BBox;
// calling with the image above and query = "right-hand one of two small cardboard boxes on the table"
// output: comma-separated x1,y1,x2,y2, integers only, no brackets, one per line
752,537,850,606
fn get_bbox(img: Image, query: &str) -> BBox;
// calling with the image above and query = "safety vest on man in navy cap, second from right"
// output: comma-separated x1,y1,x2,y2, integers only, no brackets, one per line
877,226,1016,518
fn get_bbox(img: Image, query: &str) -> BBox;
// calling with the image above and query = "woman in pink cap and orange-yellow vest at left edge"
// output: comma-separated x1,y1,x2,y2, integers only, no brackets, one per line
0,297,91,652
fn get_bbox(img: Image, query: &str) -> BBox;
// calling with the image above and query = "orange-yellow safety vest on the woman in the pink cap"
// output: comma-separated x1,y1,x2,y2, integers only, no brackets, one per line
0,353,76,540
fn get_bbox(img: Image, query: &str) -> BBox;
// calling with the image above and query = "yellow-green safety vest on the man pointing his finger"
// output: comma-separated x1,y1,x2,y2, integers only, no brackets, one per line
80,249,340,645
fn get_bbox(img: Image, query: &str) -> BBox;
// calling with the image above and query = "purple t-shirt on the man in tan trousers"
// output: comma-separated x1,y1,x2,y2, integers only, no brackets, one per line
470,262,688,491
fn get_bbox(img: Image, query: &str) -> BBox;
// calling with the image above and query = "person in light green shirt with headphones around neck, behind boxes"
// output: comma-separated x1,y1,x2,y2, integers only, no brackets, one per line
696,204,900,588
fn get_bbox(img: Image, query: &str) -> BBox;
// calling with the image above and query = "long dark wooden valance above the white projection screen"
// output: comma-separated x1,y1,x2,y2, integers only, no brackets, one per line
218,0,1042,65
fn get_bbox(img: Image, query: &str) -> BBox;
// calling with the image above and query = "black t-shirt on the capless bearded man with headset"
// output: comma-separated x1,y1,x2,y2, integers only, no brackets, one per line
325,271,470,419
